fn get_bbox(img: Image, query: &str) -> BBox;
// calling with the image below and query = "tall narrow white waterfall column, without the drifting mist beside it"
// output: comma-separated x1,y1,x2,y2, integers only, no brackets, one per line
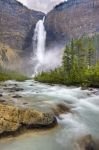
33,17,46,74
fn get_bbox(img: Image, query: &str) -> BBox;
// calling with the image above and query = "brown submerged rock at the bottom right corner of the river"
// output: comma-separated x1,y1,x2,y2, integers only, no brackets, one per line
75,135,96,150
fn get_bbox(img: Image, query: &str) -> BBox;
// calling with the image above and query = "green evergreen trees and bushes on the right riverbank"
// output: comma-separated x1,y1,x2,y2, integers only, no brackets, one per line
35,35,99,87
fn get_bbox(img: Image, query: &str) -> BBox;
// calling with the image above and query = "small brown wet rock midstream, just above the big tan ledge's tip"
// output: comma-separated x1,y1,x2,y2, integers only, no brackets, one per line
52,103,71,117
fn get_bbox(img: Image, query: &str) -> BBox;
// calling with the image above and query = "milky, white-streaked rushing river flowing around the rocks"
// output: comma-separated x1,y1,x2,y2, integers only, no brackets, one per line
0,80,99,150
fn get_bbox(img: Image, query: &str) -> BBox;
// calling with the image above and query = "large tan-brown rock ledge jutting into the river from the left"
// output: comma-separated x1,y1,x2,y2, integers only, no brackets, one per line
0,104,57,138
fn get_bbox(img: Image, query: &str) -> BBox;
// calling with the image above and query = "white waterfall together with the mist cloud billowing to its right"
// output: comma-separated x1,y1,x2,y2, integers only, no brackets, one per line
32,18,62,74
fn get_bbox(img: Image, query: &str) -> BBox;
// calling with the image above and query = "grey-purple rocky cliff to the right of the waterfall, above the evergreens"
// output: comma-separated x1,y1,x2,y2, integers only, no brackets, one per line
45,0,99,46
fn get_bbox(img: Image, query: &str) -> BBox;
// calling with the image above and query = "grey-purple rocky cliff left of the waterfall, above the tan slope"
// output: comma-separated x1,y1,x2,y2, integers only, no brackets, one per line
0,0,44,55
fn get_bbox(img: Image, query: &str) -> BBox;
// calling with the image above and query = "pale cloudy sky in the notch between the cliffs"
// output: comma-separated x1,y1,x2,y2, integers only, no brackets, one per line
18,0,64,12
